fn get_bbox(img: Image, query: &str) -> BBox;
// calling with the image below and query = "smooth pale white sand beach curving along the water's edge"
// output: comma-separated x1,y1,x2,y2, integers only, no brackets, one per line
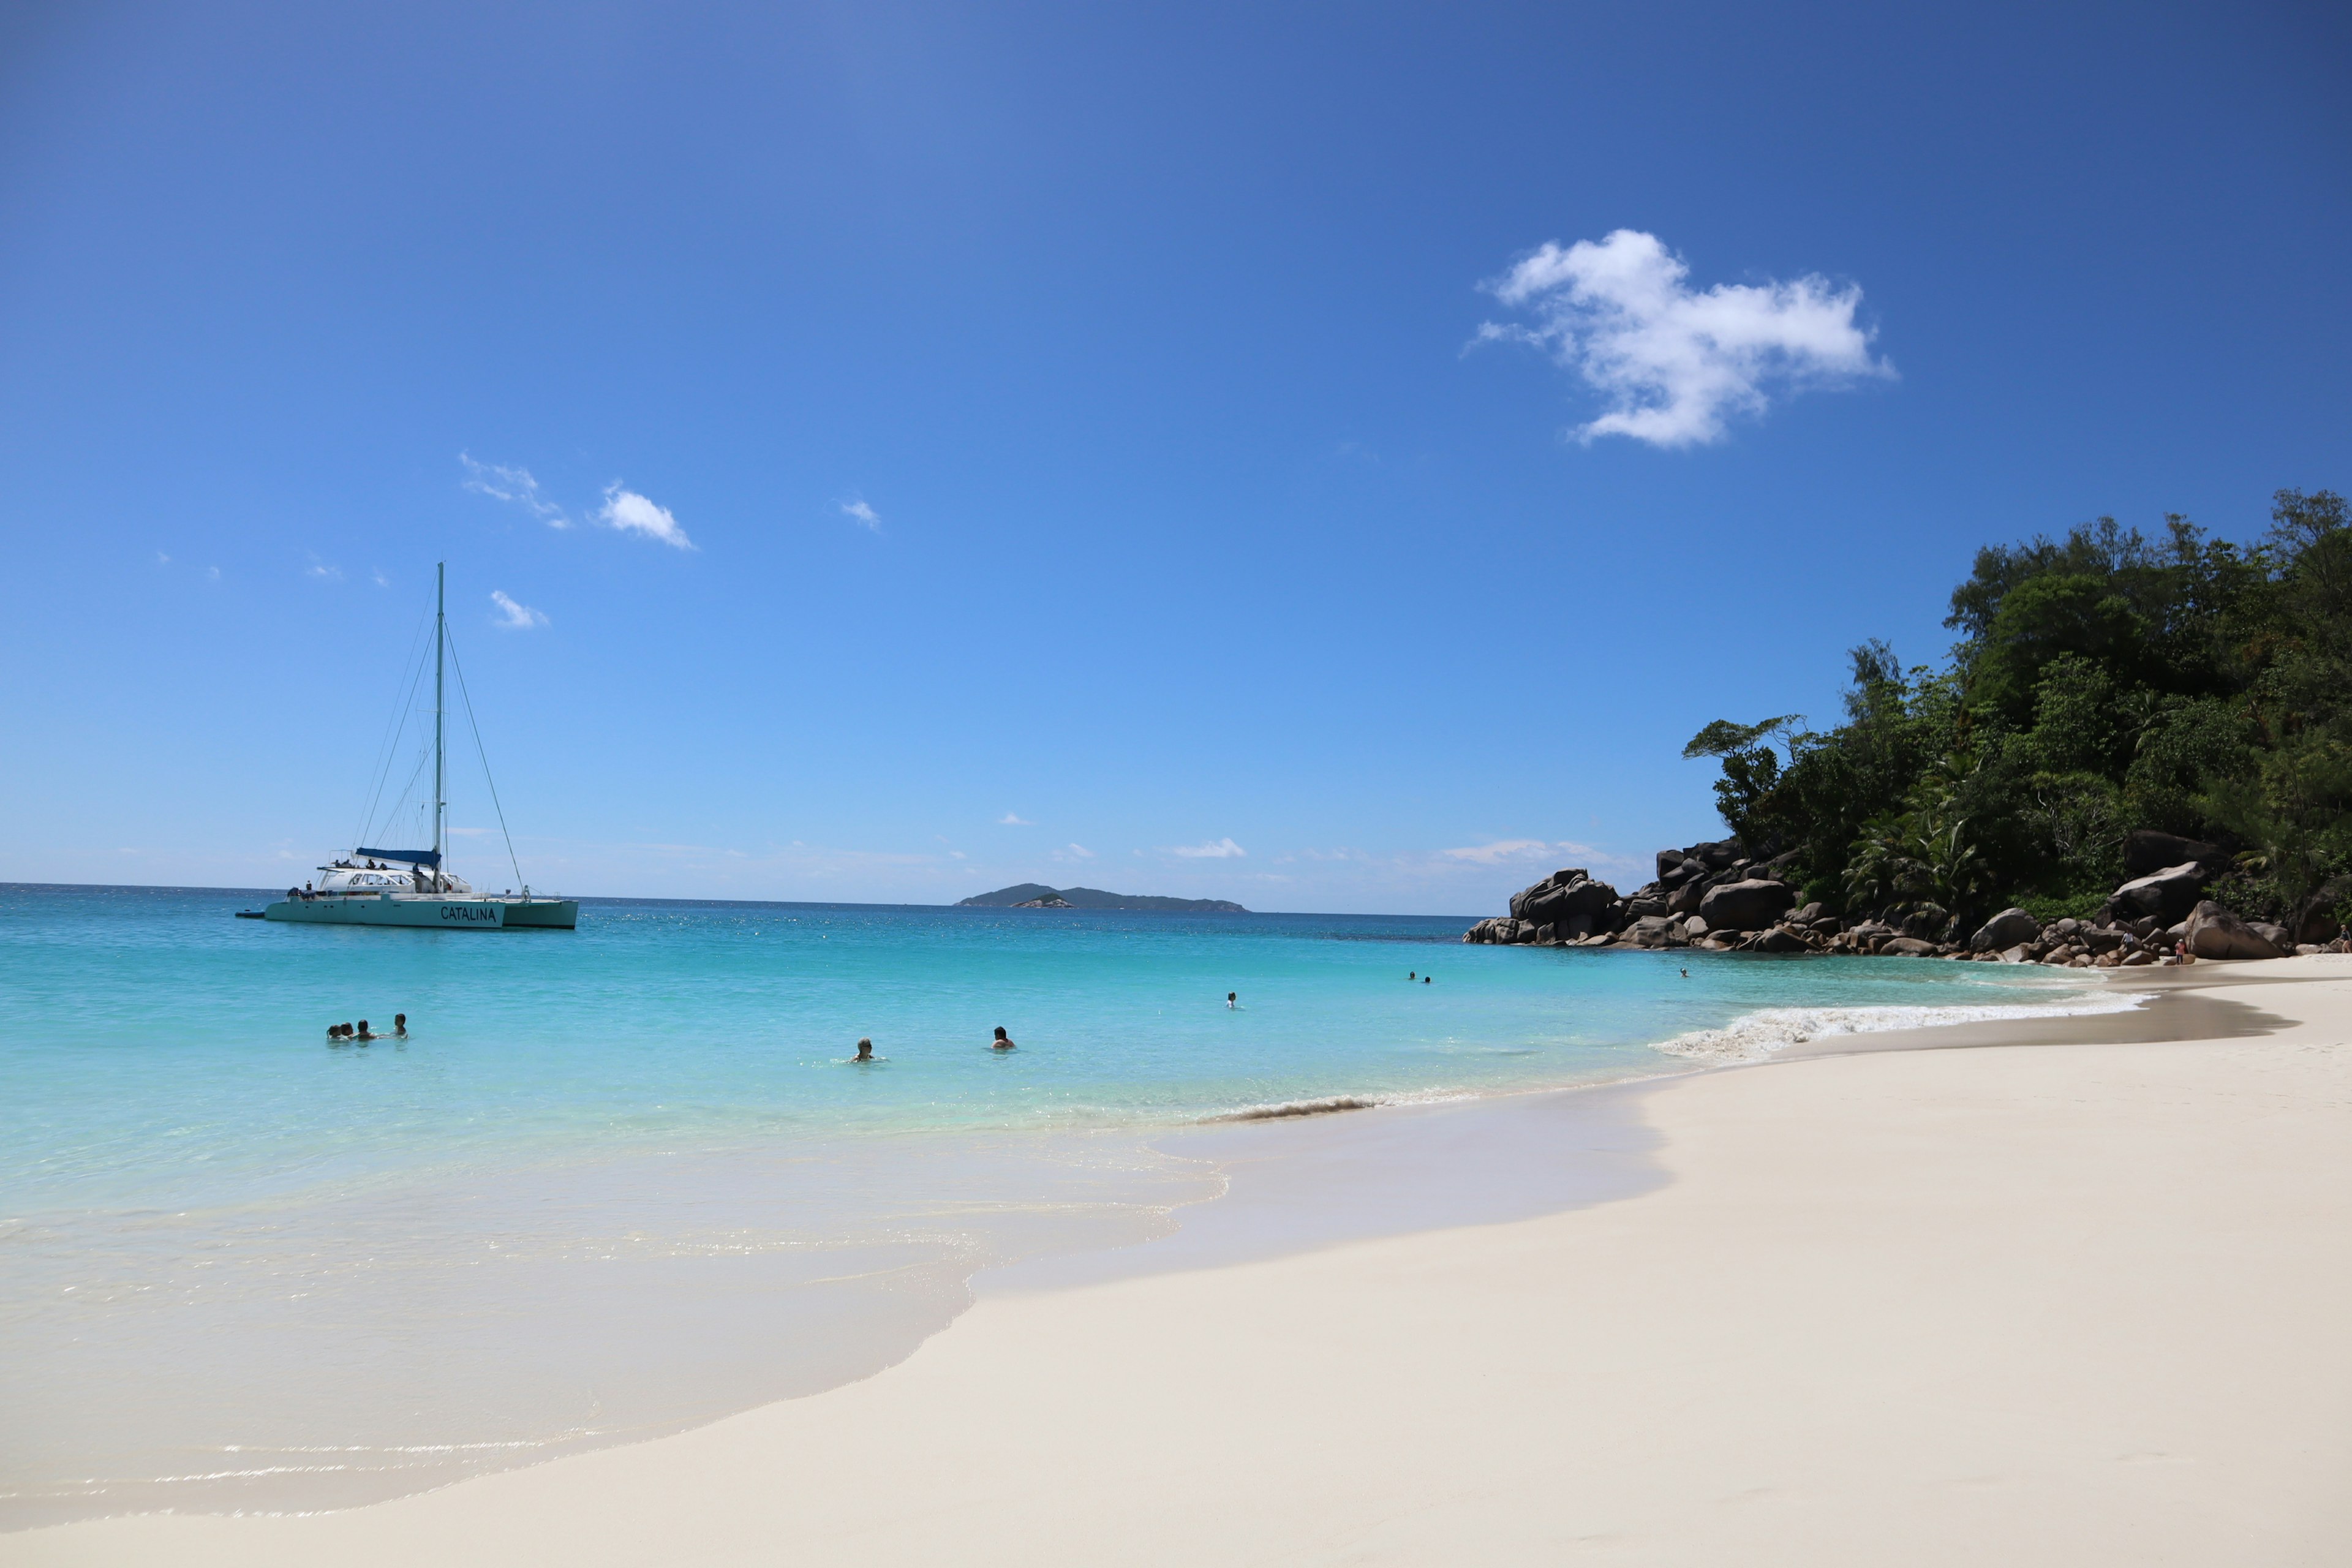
0,957,2352,1568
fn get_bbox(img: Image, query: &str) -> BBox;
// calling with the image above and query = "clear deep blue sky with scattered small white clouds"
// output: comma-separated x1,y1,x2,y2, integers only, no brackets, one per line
0,2,2352,914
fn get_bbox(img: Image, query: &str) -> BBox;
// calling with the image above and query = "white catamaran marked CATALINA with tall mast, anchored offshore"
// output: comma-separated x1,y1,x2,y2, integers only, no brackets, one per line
261,564,581,931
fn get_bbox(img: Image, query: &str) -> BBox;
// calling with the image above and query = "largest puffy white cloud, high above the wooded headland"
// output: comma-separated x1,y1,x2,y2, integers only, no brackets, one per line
1477,228,1893,447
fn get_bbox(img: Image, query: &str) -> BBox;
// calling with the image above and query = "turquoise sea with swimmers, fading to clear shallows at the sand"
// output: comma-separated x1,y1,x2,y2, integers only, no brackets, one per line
0,886,2126,1528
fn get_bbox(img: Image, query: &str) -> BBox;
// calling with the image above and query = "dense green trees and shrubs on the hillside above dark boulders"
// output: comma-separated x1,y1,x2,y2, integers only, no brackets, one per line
1684,491,2352,919
